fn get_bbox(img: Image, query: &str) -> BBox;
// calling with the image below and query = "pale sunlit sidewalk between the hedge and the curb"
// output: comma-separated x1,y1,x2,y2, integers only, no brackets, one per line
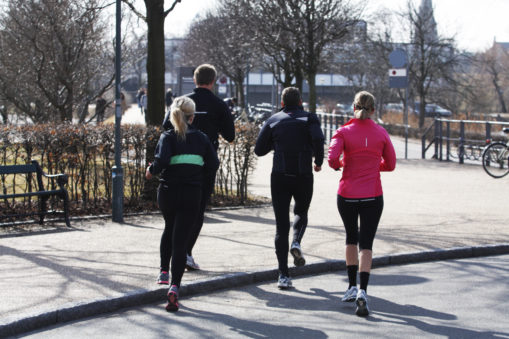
0,139,509,337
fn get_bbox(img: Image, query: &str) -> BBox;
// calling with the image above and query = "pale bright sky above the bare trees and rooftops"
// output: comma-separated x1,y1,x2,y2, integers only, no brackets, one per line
156,0,509,52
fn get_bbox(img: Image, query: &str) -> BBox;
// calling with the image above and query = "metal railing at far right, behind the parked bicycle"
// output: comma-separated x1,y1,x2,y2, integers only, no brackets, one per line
422,118,509,164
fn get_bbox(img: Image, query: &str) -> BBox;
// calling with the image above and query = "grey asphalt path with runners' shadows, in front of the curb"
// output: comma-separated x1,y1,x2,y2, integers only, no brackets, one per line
20,255,509,339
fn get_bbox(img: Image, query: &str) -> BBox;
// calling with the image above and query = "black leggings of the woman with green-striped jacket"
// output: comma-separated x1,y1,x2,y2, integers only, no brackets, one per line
157,184,202,286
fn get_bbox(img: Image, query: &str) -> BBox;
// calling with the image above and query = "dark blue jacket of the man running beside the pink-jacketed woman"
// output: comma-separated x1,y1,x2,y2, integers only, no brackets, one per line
255,106,325,175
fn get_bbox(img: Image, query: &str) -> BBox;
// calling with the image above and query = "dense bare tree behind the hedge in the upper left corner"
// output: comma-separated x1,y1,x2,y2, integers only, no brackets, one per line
0,0,113,122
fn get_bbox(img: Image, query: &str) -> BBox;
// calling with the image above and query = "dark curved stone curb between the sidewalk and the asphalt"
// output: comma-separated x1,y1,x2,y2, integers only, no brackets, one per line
0,243,509,337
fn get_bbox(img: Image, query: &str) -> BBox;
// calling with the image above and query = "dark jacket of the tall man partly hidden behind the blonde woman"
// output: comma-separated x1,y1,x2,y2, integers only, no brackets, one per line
163,87,235,150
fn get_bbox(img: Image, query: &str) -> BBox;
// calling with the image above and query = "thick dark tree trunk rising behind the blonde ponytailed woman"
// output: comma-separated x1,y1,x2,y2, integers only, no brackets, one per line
145,0,165,126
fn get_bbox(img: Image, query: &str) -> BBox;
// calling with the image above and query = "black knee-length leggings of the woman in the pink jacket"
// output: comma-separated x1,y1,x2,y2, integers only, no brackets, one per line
337,195,384,250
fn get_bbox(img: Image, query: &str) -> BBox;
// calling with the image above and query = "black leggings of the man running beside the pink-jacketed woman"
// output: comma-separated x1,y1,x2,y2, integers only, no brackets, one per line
270,173,313,276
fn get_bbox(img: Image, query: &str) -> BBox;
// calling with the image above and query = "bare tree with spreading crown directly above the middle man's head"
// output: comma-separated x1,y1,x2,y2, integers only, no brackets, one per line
226,0,361,111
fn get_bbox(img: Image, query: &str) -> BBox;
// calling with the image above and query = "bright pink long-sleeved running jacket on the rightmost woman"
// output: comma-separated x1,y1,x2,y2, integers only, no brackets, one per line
328,119,396,198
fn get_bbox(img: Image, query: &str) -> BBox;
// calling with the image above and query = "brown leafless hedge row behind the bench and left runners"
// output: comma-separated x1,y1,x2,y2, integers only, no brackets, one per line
0,124,258,215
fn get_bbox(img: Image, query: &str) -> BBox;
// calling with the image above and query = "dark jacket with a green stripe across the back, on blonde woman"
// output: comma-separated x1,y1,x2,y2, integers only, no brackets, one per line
150,126,219,187
